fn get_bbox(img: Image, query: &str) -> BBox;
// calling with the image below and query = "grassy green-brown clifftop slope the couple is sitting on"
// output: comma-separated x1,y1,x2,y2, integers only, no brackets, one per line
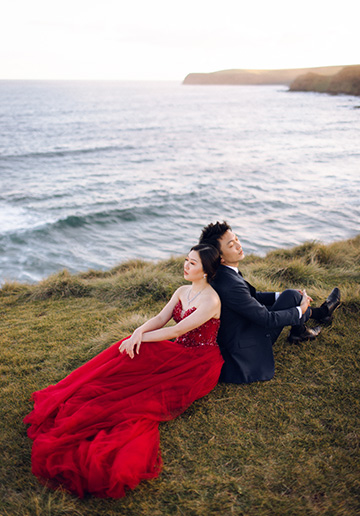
0,236,360,516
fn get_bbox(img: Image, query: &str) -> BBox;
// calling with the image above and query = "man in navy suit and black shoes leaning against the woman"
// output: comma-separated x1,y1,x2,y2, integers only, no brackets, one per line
200,222,340,383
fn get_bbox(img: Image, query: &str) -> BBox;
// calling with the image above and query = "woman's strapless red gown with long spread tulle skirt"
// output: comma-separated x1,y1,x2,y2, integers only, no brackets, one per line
24,302,223,498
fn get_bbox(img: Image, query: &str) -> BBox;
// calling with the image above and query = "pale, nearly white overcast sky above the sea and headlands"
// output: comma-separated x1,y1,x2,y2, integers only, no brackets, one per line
0,0,360,81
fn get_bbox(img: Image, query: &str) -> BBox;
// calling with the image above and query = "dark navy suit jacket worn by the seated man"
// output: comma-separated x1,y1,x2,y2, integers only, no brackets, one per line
211,265,299,383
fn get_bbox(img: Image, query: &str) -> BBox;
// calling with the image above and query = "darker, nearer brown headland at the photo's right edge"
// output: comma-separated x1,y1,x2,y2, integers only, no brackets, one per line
290,65,360,96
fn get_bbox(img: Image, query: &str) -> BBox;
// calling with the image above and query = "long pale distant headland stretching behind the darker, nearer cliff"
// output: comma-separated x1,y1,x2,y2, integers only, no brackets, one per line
183,66,343,85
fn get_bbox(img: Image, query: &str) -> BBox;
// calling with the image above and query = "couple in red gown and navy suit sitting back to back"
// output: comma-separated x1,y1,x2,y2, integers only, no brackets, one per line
24,222,340,498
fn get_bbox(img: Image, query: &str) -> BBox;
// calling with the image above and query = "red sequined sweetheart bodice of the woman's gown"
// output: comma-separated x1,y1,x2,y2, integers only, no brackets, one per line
173,301,220,348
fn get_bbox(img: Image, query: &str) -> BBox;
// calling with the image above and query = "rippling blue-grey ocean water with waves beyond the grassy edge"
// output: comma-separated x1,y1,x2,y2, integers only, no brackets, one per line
0,81,360,283
